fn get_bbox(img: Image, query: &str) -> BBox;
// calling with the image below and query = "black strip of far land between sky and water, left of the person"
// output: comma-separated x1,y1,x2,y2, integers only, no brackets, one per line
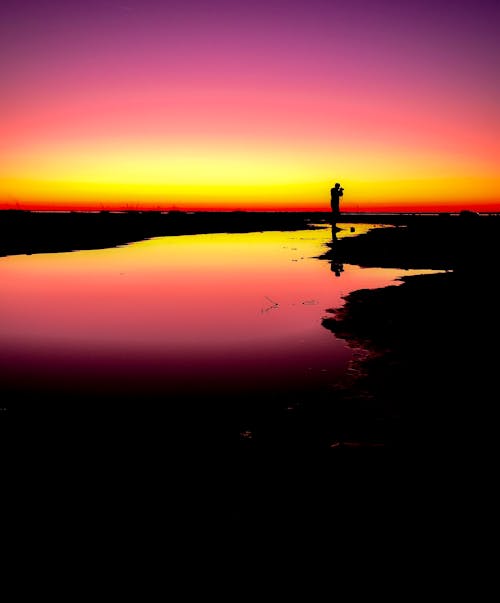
0,210,328,256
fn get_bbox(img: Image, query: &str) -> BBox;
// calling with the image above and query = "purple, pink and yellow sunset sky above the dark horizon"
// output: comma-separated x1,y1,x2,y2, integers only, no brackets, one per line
0,0,500,211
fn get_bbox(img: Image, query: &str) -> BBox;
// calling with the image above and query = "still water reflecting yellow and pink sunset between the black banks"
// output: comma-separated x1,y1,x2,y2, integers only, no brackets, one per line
0,224,436,398
